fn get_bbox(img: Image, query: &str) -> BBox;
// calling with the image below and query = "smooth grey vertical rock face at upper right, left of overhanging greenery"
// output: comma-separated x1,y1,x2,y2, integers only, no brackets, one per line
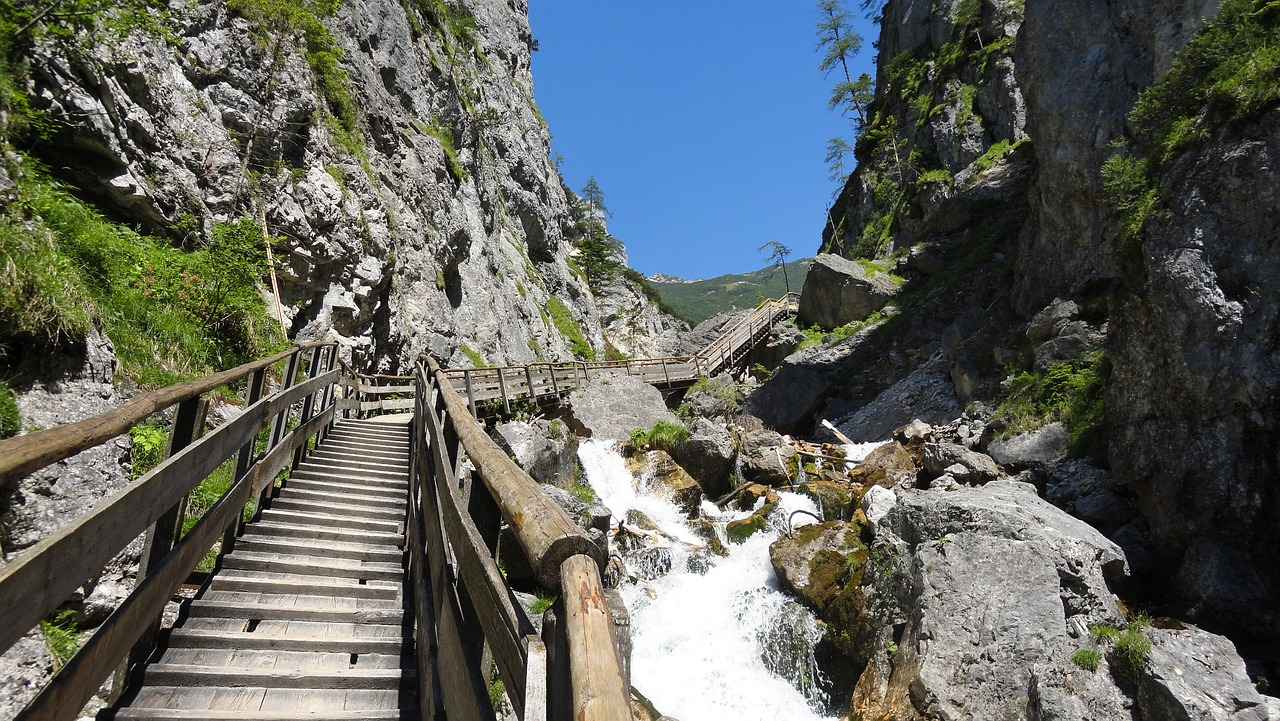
1014,0,1219,315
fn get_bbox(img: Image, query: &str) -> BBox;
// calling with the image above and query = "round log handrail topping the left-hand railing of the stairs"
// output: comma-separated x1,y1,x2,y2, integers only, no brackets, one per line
0,342,332,488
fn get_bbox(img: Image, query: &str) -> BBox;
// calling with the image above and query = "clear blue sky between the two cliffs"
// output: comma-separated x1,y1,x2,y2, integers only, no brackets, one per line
529,0,876,278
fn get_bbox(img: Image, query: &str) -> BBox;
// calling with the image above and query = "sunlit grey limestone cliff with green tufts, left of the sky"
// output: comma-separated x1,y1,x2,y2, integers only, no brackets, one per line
22,0,670,370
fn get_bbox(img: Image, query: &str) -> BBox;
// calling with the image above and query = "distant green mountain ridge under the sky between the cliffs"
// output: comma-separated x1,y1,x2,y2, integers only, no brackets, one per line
649,257,813,323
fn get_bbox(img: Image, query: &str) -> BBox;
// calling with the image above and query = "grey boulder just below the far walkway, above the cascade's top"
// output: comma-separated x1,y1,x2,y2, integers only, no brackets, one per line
567,373,680,441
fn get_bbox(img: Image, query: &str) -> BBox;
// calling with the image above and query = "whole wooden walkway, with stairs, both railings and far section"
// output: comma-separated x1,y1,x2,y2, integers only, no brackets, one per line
0,298,794,721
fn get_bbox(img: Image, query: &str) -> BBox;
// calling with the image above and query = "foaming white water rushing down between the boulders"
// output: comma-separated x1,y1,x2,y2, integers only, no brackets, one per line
579,441,826,721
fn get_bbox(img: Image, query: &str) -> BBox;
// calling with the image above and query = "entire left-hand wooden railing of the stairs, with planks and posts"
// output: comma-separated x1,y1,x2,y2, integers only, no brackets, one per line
0,343,338,720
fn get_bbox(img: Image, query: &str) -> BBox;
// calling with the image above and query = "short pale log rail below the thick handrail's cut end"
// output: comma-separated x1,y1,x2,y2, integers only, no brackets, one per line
561,556,631,721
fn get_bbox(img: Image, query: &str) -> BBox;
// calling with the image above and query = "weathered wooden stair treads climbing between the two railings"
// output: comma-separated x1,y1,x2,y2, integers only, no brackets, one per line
102,416,419,721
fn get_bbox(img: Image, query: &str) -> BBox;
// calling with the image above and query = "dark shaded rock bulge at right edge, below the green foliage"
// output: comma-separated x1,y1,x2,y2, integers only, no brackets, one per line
1107,106,1280,640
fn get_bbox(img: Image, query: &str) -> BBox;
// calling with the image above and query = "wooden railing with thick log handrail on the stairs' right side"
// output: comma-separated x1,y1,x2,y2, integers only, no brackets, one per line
407,359,631,721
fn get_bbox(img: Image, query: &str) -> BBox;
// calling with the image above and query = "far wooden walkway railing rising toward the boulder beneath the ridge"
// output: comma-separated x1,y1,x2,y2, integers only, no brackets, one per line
444,293,799,417
